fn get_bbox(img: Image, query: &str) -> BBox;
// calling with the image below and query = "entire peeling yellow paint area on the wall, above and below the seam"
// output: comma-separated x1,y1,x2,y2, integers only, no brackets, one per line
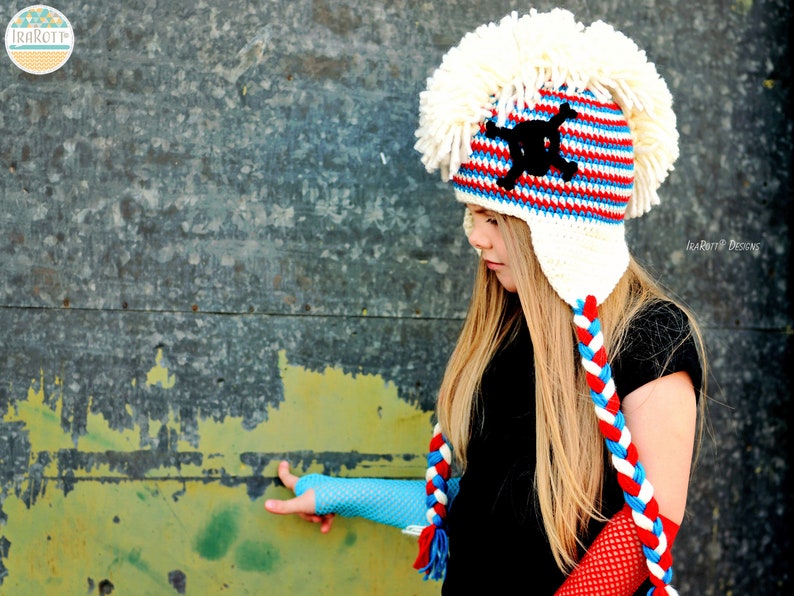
3,350,437,594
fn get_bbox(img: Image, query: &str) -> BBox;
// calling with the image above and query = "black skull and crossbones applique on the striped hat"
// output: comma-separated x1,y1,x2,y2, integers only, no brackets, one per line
485,103,579,190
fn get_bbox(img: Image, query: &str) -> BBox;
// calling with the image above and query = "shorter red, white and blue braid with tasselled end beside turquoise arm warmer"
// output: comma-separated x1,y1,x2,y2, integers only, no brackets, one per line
414,424,452,580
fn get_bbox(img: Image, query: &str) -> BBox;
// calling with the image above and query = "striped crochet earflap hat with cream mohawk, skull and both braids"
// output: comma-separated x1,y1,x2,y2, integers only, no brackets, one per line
415,9,678,594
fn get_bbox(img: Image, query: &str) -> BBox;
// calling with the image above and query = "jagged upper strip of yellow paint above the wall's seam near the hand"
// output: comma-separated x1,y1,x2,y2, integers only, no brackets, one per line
4,350,431,493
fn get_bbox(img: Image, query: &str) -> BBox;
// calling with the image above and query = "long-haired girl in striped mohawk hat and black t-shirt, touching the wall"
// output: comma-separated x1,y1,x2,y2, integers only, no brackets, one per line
265,10,703,596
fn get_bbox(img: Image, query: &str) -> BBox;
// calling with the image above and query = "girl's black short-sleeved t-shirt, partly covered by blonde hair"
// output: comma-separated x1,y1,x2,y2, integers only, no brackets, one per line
442,303,702,596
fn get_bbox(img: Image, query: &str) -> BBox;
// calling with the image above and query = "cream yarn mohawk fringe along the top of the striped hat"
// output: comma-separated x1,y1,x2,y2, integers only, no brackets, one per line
415,8,678,218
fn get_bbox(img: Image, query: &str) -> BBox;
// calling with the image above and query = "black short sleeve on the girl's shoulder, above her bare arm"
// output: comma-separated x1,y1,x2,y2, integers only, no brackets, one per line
612,302,703,398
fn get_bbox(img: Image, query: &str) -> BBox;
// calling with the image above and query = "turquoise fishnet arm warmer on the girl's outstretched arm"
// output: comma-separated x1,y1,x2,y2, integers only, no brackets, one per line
295,474,460,529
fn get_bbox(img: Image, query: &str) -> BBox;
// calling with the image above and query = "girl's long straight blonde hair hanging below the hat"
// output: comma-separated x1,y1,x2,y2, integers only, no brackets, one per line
437,215,704,571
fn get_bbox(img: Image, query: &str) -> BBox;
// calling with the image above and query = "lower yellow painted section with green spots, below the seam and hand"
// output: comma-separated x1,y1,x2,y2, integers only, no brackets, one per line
2,480,438,596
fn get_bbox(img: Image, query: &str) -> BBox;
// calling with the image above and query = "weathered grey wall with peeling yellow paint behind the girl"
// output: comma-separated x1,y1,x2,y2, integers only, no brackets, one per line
0,0,792,595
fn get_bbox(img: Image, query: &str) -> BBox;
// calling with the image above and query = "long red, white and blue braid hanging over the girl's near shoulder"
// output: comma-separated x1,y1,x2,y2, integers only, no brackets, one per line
573,296,678,596
